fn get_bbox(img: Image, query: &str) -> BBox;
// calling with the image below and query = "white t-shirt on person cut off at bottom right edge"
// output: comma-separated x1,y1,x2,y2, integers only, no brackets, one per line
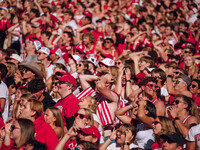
185,124,200,149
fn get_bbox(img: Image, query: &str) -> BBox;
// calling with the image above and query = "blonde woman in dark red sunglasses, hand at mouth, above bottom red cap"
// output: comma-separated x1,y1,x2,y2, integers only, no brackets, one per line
55,108,94,150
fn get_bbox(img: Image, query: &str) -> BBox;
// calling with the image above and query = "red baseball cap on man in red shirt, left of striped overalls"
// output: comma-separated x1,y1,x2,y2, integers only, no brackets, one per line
57,72,77,87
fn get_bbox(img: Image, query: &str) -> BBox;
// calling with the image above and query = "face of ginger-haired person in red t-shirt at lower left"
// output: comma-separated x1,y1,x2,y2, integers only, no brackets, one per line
19,102,35,119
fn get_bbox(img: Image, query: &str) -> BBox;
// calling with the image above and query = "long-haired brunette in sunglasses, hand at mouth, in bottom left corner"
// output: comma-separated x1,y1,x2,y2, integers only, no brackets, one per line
1,119,35,150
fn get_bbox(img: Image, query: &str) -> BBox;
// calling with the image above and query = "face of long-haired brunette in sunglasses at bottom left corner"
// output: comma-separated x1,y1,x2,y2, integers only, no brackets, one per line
10,121,21,141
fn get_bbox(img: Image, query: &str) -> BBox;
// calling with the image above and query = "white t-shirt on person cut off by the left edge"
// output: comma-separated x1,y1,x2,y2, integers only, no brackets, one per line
0,81,9,122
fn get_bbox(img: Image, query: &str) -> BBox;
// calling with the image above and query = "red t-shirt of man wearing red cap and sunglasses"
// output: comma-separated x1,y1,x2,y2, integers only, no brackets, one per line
55,94,79,126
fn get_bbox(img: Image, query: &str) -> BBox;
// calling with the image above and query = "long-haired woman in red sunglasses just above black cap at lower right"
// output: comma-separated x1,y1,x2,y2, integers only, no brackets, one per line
151,116,176,150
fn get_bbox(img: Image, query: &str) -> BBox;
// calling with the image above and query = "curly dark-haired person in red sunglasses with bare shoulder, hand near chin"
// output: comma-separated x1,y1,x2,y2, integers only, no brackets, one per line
138,77,165,116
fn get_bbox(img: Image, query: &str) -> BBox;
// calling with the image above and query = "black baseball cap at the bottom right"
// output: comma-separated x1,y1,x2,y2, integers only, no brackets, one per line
160,132,185,145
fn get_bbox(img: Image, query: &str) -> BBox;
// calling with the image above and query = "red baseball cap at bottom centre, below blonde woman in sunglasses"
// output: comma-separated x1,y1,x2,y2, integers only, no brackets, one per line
81,125,101,141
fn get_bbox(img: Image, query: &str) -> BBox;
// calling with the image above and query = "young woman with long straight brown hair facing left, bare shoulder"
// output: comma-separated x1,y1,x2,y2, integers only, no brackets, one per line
44,107,64,140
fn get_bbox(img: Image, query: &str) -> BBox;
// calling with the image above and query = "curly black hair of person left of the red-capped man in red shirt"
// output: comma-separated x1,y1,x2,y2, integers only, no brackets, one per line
28,78,45,93
